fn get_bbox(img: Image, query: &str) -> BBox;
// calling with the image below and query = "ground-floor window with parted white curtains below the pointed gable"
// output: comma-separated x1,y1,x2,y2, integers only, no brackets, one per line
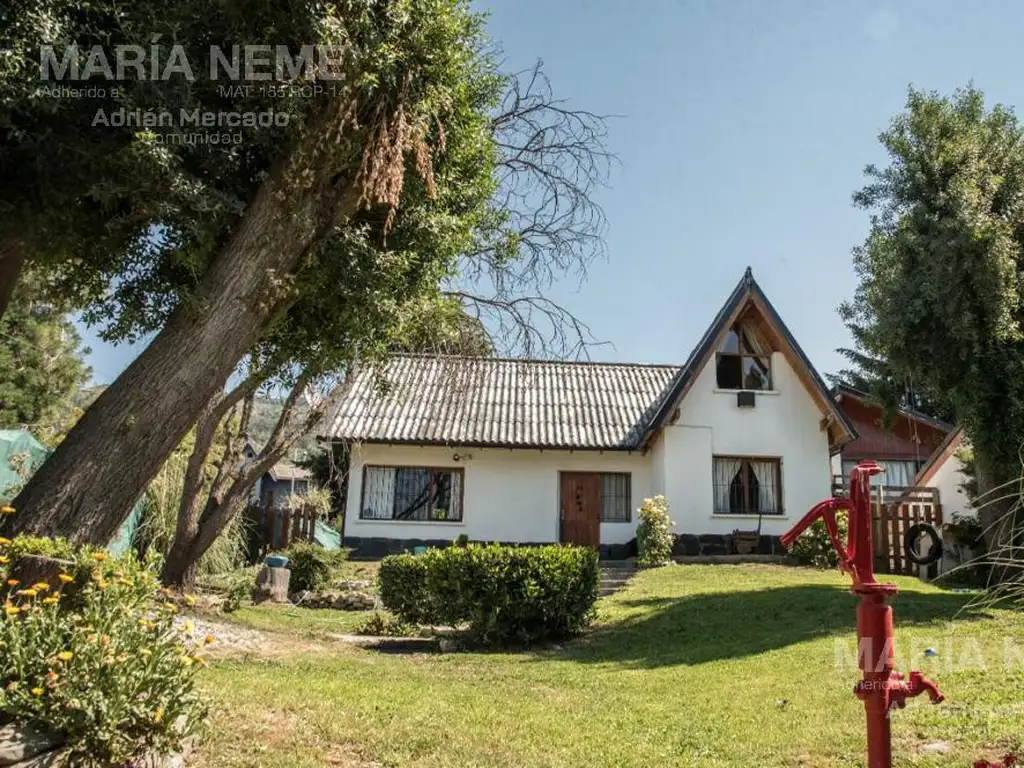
712,456,783,515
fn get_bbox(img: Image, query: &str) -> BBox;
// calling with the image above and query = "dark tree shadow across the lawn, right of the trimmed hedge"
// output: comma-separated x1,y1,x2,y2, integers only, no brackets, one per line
563,585,986,668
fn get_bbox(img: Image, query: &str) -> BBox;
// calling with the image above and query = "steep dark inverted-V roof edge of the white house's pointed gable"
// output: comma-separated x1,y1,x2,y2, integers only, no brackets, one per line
644,267,857,445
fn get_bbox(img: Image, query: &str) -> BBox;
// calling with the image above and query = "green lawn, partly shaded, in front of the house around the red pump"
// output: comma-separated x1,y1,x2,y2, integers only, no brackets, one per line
196,565,1024,768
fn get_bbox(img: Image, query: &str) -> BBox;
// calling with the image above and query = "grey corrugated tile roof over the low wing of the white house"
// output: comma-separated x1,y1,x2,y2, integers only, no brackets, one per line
330,355,681,450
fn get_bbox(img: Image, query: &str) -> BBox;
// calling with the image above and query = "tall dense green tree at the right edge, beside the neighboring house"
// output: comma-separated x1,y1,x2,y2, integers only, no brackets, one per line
843,87,1024,541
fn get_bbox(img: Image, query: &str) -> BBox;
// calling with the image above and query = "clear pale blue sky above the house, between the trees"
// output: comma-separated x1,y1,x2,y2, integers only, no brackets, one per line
75,0,1024,382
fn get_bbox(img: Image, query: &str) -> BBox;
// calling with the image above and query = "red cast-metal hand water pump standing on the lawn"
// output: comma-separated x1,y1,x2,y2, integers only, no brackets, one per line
781,462,943,768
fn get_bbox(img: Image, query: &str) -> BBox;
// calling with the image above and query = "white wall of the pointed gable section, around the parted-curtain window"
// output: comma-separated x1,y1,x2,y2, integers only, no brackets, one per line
665,352,831,536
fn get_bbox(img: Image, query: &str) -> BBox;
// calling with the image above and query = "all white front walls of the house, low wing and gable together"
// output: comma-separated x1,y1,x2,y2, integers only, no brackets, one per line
345,353,835,544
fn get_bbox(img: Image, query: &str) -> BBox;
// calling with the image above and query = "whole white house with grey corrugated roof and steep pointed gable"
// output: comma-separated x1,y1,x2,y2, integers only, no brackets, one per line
324,268,856,557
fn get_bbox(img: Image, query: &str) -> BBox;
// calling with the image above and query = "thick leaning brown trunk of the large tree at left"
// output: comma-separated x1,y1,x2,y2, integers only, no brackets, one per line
0,98,360,545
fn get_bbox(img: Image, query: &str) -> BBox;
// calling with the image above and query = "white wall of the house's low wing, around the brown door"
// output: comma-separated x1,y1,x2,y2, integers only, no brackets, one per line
345,444,651,544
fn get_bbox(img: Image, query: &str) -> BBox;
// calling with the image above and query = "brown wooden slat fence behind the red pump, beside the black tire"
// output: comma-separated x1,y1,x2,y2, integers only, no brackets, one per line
833,479,942,575
